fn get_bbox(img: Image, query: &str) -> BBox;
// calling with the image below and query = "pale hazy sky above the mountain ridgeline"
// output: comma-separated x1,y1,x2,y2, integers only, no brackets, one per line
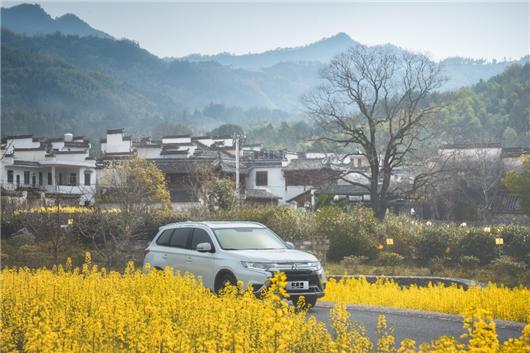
4,1,530,59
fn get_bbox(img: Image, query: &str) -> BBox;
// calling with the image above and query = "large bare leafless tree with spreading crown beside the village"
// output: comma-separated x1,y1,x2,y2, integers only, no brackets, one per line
304,46,443,219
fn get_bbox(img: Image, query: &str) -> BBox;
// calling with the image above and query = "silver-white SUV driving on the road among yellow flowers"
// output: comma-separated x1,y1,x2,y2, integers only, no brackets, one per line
144,222,326,306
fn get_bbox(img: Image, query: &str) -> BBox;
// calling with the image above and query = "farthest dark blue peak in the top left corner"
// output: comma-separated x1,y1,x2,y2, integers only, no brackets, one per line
1,4,111,38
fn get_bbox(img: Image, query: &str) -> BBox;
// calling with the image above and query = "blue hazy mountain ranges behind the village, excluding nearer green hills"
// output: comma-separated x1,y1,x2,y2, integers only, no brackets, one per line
1,5,528,140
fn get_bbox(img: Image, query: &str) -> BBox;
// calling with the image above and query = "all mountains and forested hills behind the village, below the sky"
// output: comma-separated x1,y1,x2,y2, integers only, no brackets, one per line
1,5,530,144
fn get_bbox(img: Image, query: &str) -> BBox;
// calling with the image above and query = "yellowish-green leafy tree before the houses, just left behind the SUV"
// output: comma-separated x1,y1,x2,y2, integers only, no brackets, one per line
75,157,171,268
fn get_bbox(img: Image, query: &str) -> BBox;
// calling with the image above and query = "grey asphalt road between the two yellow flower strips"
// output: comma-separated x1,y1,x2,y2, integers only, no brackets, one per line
310,303,524,344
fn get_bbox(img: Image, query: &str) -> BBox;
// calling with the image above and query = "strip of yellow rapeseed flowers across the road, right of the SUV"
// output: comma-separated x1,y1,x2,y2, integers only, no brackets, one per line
322,277,530,322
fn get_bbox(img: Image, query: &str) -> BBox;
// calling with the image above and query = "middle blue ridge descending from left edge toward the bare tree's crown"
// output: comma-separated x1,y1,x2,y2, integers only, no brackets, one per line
2,31,317,111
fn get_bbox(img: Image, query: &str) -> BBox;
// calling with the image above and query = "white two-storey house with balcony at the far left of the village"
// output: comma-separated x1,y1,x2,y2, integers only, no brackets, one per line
0,134,96,205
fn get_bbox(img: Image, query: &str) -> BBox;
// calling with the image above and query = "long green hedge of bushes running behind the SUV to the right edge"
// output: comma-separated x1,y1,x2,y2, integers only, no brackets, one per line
2,206,530,265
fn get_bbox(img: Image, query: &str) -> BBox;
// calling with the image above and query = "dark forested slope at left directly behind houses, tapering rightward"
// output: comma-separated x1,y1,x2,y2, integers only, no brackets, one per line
1,38,156,135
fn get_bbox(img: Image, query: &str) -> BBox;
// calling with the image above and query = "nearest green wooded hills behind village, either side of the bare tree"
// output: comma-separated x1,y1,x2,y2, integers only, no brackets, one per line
243,63,530,150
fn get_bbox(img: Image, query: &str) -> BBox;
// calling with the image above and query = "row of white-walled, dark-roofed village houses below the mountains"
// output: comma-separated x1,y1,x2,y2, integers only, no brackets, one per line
0,129,530,219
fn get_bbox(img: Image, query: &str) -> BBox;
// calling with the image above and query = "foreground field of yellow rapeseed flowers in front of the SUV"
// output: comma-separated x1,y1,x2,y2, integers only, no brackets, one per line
0,257,530,353
